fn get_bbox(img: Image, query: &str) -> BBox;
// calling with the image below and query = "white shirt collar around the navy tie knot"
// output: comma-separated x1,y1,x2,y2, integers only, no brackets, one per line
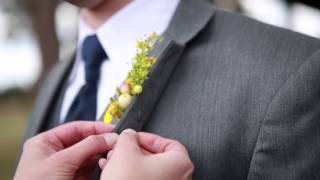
78,0,180,64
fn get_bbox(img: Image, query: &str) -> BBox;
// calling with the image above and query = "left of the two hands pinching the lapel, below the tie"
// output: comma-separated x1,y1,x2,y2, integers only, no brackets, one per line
14,122,118,180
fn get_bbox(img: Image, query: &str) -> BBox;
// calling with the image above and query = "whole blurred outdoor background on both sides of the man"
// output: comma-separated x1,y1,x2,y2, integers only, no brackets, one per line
0,0,320,180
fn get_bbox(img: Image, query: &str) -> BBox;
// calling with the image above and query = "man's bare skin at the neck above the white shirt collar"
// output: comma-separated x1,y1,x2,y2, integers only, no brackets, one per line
80,0,132,30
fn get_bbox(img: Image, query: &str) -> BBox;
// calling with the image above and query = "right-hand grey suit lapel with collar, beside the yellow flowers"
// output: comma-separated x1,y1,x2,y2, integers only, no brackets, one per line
109,0,214,133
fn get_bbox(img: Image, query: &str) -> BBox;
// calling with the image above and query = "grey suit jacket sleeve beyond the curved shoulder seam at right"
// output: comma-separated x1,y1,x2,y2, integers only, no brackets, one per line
247,49,320,180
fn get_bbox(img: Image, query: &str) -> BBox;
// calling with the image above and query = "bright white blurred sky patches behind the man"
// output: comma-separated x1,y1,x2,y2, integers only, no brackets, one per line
0,0,320,92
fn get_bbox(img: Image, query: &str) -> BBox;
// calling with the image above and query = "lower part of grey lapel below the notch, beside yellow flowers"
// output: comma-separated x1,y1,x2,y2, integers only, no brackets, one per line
115,41,184,133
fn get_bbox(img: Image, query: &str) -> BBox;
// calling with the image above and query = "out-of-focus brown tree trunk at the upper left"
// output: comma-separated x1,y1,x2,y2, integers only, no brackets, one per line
0,0,59,89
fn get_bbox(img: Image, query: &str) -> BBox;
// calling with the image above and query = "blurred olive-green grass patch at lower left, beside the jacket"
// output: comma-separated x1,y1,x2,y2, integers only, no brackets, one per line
0,90,32,179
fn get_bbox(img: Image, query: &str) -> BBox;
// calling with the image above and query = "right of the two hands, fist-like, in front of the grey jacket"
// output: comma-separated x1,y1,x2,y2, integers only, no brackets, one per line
99,130,194,180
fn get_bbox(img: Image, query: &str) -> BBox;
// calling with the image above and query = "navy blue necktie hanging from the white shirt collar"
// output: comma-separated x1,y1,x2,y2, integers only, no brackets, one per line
65,35,107,122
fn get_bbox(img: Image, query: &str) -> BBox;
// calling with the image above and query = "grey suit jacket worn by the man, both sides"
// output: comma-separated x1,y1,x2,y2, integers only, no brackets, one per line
24,0,320,180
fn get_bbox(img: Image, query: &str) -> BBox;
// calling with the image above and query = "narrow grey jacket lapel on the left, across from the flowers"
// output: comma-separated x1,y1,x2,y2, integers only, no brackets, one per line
26,55,74,138
